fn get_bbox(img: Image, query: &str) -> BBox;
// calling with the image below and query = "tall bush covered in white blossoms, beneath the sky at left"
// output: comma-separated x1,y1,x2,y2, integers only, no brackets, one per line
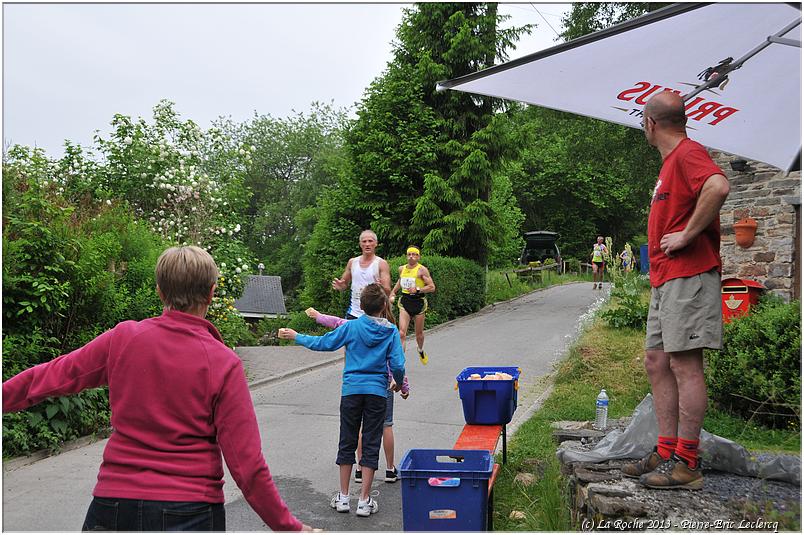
4,100,256,345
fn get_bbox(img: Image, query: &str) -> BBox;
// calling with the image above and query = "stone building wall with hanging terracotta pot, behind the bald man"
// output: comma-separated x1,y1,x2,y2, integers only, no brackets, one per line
712,151,801,301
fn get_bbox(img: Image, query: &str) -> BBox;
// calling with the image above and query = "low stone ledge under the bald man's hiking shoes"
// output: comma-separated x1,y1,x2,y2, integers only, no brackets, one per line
553,418,801,533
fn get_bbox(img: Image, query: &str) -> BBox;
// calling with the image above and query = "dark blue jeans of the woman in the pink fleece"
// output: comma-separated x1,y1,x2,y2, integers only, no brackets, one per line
81,497,226,531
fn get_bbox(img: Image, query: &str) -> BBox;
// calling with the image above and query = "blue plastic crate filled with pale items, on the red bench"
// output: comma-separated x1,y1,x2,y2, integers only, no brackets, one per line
456,366,521,425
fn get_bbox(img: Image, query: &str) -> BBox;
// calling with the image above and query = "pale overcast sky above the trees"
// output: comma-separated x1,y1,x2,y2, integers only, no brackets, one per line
3,3,569,157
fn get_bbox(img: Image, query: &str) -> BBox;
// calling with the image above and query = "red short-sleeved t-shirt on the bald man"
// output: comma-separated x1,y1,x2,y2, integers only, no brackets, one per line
648,138,724,288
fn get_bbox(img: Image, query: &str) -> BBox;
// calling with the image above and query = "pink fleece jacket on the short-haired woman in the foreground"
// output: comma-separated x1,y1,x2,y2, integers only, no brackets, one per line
3,310,302,531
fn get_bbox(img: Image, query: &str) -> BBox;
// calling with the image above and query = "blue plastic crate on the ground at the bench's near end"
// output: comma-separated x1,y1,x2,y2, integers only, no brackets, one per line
399,449,494,531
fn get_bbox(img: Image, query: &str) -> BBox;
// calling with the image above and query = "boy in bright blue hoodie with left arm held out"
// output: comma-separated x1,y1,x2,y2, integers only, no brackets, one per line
279,283,405,516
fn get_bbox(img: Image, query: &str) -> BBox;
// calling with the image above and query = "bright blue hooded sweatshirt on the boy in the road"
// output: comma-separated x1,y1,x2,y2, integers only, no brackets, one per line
296,314,405,396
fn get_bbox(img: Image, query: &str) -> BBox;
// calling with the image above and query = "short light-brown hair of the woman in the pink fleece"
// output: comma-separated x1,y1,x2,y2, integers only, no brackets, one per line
156,245,220,312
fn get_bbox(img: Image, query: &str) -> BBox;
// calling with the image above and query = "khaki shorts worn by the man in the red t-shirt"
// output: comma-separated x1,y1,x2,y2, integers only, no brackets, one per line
645,269,723,353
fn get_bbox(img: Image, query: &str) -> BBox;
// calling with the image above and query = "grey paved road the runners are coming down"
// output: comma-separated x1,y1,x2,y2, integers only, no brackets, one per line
3,284,602,531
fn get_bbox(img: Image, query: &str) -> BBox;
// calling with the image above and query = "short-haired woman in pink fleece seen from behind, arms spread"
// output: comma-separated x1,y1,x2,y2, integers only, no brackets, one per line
3,246,310,531
